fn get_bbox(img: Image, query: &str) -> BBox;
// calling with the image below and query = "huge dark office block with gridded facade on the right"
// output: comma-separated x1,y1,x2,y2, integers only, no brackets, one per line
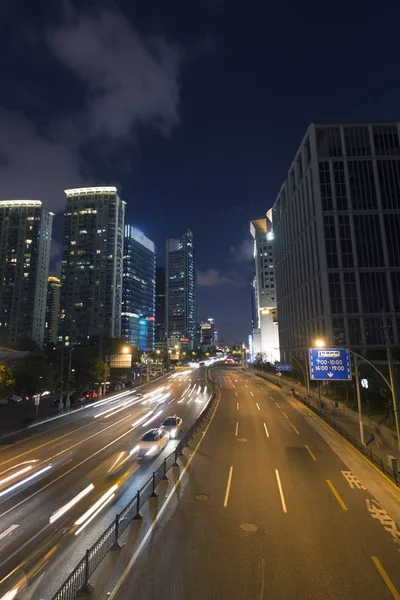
273,122,400,360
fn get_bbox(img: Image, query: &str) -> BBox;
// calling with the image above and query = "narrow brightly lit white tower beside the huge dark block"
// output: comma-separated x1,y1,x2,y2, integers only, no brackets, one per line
250,212,280,363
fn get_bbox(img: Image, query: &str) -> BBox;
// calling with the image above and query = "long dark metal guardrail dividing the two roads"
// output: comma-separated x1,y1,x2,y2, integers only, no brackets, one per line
52,372,216,600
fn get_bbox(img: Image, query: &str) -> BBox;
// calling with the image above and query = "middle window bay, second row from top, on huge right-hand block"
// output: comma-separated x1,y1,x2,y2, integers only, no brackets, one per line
348,160,378,210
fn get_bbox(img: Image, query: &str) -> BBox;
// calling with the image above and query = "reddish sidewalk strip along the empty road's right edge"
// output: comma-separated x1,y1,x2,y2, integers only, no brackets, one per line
252,370,400,472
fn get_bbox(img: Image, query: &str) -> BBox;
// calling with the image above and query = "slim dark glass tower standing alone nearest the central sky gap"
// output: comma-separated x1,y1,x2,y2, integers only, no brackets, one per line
165,230,196,347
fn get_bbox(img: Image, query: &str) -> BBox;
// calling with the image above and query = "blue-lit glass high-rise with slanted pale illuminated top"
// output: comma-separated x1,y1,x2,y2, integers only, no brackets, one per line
122,225,156,352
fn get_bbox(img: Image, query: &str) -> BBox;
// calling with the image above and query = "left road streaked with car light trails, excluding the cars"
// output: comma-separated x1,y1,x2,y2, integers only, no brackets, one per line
0,369,209,600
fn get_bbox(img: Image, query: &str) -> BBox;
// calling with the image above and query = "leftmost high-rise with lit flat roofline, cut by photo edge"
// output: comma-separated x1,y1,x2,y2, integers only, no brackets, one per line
0,200,54,348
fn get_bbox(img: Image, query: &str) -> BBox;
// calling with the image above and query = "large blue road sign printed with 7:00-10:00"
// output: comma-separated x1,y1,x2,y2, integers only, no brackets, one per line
308,348,351,381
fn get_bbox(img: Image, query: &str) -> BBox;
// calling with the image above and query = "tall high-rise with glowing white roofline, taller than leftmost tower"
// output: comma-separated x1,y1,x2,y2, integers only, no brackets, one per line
60,187,125,344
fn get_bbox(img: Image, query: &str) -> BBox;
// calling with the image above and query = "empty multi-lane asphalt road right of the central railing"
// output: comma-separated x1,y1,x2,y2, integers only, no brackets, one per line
108,368,400,600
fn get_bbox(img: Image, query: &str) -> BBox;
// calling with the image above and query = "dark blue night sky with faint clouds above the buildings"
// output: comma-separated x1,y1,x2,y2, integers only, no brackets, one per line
0,0,400,341
